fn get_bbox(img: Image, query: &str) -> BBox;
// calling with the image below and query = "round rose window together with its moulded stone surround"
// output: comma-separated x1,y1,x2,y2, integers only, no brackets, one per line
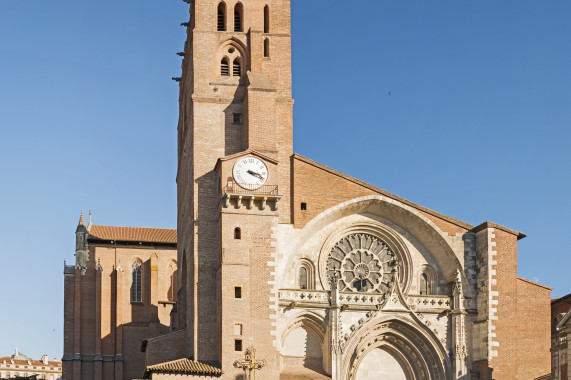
319,223,411,296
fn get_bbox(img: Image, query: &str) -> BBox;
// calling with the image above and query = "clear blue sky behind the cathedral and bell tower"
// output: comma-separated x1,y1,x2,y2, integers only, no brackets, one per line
0,0,571,358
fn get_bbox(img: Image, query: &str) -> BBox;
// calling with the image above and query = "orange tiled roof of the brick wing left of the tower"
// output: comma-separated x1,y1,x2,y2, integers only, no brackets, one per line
89,225,176,244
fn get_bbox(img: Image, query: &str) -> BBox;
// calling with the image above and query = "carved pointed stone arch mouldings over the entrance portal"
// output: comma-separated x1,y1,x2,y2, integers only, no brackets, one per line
343,315,452,380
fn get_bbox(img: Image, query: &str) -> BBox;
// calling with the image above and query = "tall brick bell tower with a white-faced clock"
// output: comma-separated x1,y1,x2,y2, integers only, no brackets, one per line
177,0,293,379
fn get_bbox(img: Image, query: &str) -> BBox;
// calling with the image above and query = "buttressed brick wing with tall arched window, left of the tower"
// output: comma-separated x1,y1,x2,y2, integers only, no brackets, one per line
62,217,177,380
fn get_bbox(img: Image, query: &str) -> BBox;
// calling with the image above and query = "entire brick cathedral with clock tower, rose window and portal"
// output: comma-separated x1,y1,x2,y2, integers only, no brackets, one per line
64,0,551,380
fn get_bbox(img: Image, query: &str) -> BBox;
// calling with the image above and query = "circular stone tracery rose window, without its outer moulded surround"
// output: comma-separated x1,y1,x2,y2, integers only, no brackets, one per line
326,234,397,293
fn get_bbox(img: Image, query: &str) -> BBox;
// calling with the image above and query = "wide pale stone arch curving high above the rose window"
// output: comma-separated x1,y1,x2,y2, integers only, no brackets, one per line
284,195,464,288
